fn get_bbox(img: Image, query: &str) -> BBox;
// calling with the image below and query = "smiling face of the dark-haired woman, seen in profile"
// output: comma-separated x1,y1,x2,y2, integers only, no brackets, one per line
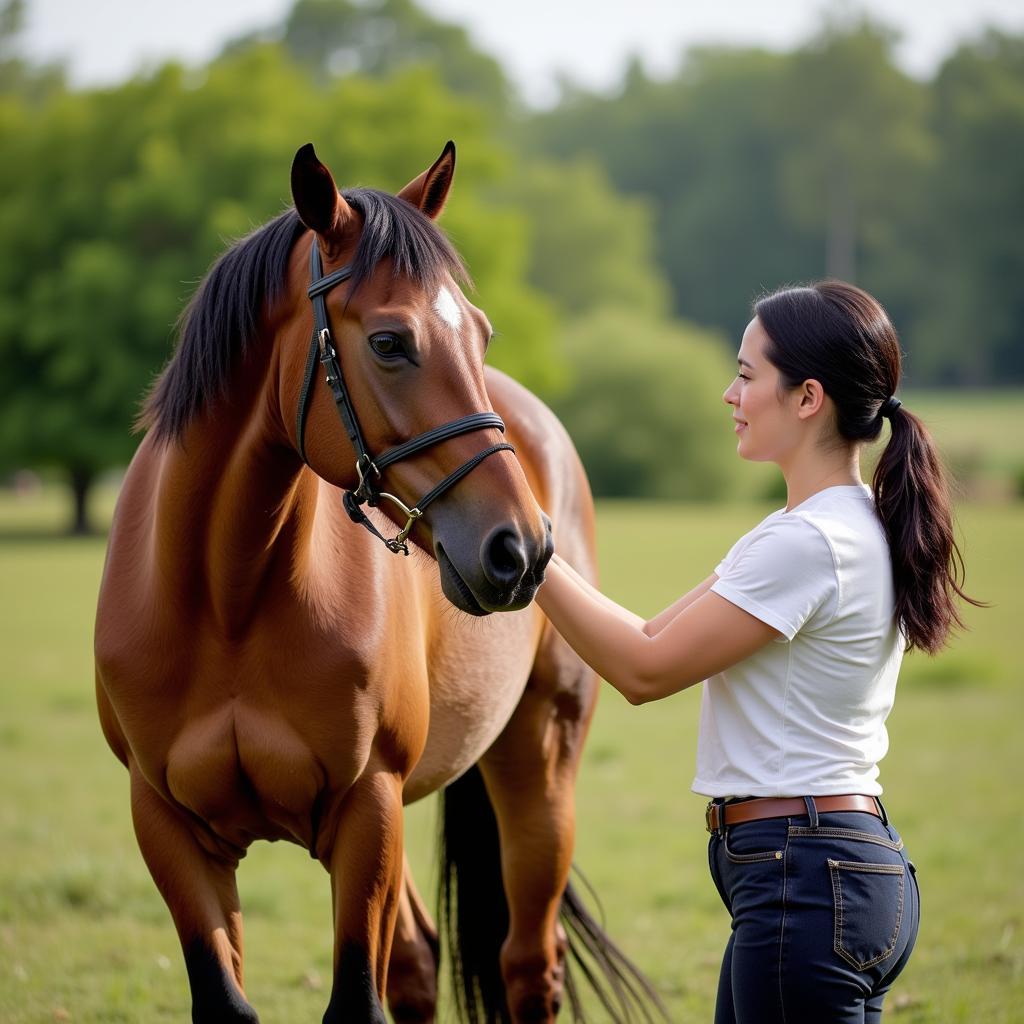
722,316,802,463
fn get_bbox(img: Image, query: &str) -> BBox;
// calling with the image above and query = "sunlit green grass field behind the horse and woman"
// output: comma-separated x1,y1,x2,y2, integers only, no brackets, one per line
0,495,1024,1024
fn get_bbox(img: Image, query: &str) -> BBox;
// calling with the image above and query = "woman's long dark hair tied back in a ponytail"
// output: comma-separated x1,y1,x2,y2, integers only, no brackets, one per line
754,281,980,654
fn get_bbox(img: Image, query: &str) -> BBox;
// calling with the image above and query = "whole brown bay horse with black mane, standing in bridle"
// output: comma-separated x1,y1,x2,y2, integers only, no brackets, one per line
95,142,656,1024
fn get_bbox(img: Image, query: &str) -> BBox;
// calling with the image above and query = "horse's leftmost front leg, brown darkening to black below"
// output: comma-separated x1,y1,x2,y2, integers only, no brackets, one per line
129,763,259,1024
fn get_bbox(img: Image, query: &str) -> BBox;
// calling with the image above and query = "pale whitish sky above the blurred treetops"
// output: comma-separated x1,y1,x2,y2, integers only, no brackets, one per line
24,0,1024,106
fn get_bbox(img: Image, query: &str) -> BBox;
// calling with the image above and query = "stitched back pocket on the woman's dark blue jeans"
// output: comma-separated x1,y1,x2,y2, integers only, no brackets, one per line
828,858,904,971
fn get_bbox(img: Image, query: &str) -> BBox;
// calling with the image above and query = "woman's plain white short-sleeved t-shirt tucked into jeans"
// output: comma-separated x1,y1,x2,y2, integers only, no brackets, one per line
693,485,904,797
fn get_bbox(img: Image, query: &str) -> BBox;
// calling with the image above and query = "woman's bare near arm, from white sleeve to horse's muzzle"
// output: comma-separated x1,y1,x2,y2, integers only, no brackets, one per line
537,561,781,703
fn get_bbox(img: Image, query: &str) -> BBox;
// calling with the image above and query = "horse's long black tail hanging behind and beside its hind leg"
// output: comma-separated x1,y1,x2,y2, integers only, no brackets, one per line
437,766,668,1024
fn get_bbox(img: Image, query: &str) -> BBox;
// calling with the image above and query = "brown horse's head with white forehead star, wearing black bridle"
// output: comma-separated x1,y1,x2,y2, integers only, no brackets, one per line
282,142,552,615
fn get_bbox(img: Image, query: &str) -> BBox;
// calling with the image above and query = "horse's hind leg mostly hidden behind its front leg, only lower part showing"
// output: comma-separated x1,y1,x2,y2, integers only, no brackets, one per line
387,859,440,1024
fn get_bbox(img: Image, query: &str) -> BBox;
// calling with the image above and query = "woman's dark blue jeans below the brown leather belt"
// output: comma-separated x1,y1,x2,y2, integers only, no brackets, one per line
708,808,921,1024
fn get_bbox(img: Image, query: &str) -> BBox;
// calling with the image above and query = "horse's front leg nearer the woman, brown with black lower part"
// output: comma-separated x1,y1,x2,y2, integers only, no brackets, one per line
324,771,402,1024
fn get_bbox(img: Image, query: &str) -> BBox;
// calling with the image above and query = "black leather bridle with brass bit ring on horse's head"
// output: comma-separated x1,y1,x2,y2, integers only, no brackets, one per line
295,239,515,555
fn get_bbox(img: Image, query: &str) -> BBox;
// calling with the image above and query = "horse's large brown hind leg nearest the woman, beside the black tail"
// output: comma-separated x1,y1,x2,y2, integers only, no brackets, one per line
480,628,597,1024
